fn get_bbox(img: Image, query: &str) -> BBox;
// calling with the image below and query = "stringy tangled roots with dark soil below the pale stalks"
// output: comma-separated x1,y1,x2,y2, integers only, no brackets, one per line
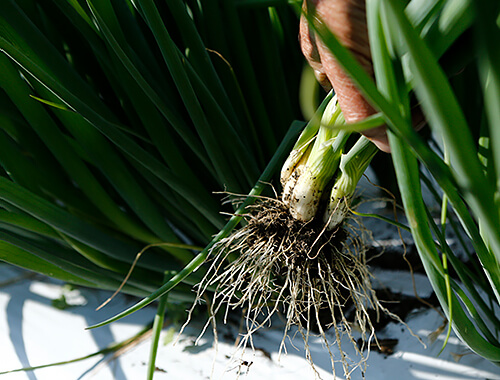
186,198,397,378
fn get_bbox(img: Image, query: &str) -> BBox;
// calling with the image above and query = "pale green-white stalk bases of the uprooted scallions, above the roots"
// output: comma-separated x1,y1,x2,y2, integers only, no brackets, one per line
282,96,377,229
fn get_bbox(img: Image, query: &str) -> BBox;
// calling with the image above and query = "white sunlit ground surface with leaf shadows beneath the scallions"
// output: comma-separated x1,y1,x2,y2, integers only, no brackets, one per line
0,176,500,380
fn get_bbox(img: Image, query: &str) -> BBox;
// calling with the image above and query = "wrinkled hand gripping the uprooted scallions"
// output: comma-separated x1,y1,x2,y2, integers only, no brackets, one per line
300,0,390,152
